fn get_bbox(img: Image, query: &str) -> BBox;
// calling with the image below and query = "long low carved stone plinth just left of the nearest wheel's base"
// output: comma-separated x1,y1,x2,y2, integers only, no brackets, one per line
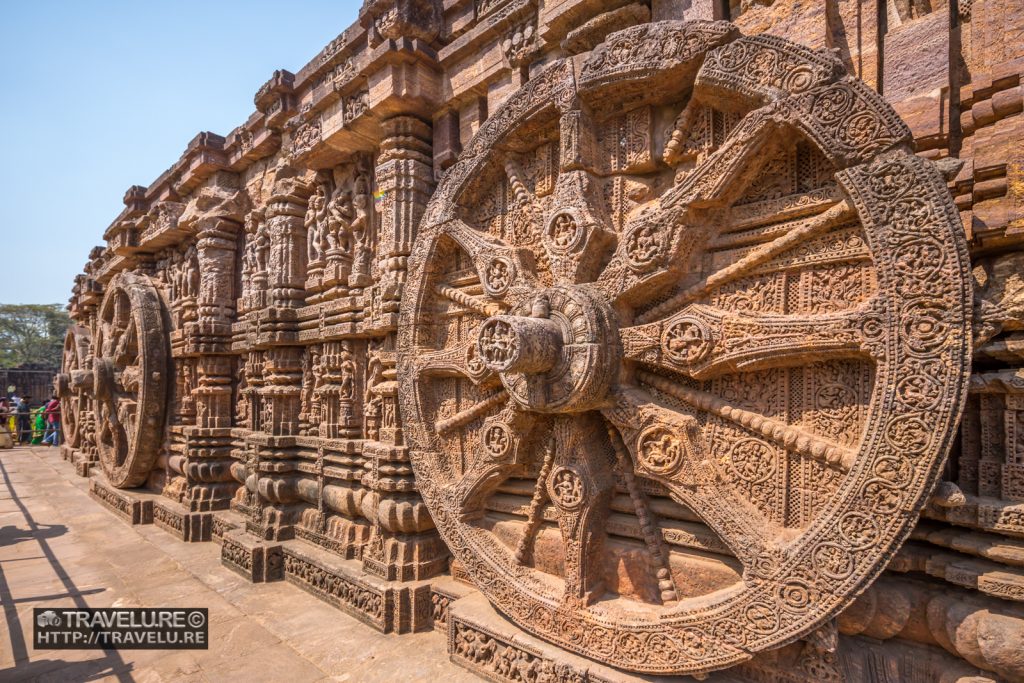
283,541,431,633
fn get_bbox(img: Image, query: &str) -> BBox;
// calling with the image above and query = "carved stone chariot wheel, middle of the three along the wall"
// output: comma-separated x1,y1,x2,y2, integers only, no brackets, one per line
92,273,170,488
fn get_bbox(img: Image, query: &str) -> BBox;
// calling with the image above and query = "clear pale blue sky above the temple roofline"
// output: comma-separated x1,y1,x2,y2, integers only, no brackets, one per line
0,0,360,303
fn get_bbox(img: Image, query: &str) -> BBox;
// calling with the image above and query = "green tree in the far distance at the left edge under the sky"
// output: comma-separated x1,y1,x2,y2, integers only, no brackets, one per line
0,303,71,370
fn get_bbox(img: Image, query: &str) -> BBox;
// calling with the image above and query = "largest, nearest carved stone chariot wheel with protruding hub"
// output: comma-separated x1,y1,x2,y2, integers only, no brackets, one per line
399,22,971,674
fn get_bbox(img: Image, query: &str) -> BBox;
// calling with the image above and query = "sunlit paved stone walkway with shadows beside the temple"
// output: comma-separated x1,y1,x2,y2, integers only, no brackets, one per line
0,446,479,683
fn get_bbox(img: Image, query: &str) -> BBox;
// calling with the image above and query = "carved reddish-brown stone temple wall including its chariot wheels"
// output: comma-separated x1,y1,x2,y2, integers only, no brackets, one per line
56,0,1024,682
